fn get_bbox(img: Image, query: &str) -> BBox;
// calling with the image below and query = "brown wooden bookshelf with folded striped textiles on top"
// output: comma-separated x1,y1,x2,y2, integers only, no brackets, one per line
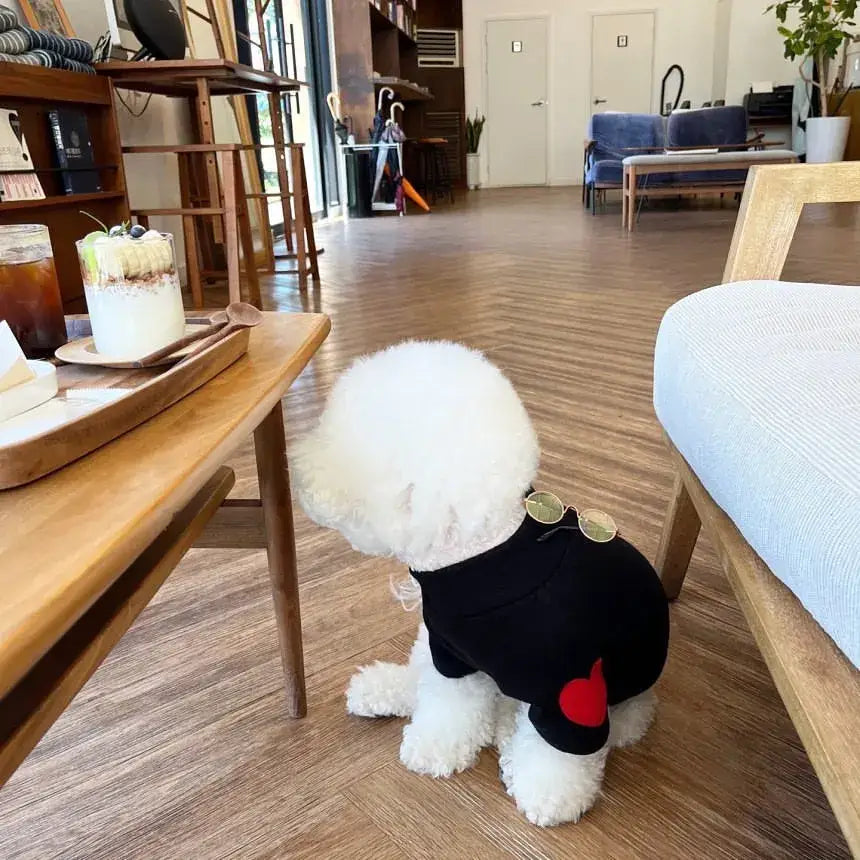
0,62,129,313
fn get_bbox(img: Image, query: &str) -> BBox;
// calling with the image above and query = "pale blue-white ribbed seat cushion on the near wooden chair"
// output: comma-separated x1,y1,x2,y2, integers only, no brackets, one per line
654,281,860,666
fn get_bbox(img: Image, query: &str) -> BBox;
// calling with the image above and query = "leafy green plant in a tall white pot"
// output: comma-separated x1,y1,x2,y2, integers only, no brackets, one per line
766,0,860,163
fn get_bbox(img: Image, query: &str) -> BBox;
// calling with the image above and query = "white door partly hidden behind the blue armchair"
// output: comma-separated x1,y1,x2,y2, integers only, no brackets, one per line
591,12,654,113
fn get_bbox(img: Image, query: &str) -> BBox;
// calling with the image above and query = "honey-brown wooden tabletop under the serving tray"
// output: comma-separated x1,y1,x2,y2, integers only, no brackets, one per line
0,313,330,697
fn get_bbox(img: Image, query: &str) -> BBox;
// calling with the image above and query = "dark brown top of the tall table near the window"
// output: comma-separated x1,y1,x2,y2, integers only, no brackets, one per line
95,59,307,96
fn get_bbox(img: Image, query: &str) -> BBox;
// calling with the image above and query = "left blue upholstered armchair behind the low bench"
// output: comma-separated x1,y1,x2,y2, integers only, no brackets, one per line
583,113,665,212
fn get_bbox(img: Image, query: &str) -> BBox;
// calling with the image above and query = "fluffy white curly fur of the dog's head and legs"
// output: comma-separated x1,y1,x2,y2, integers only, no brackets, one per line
291,341,655,826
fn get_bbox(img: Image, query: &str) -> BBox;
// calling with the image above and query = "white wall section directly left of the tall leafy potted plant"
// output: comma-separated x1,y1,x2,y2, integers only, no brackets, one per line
726,0,797,104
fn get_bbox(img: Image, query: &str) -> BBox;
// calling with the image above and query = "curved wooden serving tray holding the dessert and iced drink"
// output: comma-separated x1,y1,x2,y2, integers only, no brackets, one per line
0,315,251,490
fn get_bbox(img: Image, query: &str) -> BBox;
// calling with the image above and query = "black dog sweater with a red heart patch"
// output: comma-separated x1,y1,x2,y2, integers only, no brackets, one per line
412,512,669,755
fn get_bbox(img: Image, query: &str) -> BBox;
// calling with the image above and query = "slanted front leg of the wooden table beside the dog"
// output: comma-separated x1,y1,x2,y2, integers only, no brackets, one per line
254,403,307,717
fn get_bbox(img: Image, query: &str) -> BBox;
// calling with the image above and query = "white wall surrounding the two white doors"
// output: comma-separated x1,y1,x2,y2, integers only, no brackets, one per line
463,0,720,185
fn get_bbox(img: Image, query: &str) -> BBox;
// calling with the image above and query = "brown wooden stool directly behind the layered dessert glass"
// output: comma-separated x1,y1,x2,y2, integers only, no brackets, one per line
123,143,262,308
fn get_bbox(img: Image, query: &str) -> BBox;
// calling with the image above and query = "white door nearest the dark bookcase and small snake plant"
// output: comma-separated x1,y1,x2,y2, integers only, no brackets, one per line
486,18,547,185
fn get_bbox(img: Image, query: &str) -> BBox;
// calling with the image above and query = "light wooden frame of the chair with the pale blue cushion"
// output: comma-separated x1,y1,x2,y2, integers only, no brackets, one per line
656,162,860,857
